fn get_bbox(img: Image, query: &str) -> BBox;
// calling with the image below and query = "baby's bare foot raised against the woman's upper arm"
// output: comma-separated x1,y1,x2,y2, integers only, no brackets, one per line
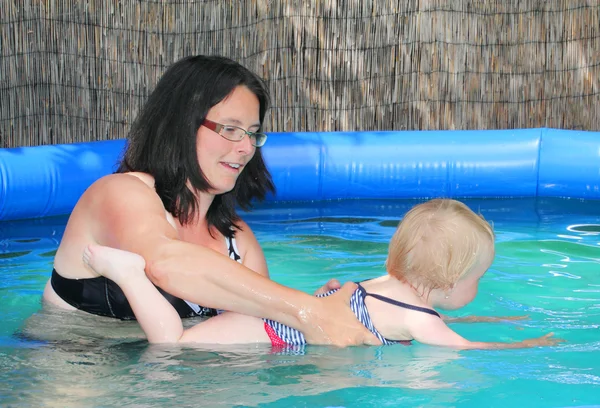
83,245,146,284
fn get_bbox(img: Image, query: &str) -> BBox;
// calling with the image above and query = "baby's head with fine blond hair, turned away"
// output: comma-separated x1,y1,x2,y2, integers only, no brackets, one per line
386,199,494,309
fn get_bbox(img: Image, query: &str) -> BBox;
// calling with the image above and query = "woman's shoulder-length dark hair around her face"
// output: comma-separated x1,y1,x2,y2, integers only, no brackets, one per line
117,55,275,236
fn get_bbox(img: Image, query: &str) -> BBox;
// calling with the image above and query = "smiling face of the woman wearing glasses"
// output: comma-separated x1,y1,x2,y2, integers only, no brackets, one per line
196,86,260,194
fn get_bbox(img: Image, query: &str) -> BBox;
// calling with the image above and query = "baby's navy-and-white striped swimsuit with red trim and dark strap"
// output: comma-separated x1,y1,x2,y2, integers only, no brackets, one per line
263,283,440,347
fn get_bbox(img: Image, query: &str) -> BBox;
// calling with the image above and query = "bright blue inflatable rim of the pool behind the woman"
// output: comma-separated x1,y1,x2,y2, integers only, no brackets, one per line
0,128,600,220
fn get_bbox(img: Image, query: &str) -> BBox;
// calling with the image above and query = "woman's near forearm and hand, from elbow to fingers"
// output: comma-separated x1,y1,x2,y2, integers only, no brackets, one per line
146,242,378,346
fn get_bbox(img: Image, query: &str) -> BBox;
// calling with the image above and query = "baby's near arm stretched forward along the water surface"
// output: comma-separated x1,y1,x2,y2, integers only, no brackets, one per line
406,315,563,349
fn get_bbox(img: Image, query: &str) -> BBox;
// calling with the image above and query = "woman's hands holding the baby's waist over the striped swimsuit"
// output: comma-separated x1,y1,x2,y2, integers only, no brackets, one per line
299,281,381,347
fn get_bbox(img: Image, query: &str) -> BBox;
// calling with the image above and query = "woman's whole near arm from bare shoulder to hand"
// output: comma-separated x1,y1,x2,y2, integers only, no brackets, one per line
88,174,378,346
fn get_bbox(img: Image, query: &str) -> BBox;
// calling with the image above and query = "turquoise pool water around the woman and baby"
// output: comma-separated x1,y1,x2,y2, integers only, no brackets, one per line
0,199,600,407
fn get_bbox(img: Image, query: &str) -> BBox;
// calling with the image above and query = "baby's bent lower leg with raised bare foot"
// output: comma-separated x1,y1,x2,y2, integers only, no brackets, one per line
83,245,183,343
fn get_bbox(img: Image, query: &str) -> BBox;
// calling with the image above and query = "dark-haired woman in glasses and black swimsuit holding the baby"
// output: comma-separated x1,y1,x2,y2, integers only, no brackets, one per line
43,56,378,346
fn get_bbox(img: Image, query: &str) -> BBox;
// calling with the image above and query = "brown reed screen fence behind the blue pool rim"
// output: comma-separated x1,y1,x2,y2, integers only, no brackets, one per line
0,0,600,147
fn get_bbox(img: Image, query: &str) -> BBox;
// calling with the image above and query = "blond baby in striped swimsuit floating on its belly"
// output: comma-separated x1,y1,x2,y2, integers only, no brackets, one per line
83,199,561,349
